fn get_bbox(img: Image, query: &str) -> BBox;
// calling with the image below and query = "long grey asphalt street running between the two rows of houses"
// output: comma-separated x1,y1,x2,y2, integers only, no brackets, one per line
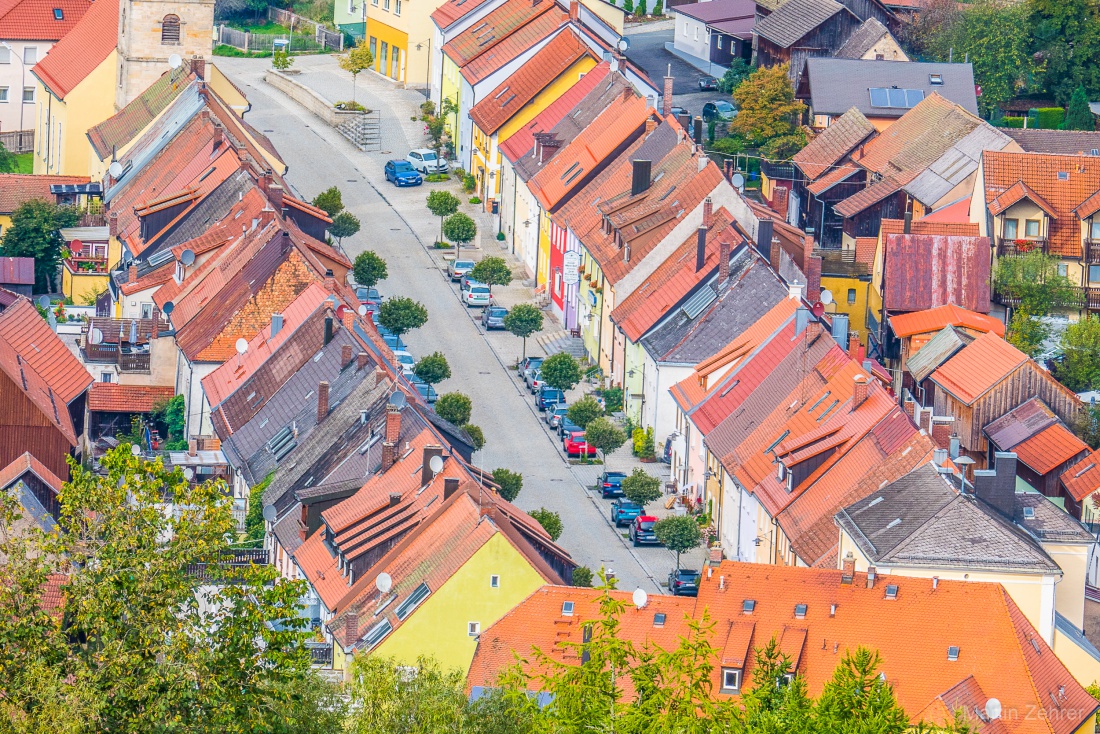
216,56,703,592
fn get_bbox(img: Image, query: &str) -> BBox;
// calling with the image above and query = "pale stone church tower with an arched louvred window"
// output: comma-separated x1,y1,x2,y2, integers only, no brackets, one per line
114,0,213,109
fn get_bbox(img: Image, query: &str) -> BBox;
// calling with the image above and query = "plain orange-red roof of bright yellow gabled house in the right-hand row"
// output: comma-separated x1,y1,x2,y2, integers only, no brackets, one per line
470,31,592,135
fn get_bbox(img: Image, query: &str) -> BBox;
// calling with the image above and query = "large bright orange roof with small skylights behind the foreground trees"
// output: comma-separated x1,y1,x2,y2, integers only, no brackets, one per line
468,561,1098,734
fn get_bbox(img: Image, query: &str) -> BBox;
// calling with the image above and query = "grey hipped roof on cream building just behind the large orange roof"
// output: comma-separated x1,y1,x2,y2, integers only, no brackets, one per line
836,463,1060,574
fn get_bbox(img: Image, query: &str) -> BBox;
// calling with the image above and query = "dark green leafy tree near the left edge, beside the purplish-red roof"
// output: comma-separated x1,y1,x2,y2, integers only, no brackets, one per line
0,199,80,293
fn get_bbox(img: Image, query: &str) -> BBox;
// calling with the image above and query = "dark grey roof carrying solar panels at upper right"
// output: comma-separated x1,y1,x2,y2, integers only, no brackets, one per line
800,58,978,118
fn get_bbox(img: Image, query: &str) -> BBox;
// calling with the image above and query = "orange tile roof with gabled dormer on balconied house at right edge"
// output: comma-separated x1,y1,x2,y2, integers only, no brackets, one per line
982,151,1100,258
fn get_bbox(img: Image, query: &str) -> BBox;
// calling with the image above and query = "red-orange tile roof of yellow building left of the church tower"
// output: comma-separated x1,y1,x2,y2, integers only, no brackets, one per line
31,0,119,99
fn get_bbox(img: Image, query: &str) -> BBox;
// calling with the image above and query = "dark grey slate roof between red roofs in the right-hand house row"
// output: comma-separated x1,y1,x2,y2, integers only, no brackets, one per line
641,248,793,365
